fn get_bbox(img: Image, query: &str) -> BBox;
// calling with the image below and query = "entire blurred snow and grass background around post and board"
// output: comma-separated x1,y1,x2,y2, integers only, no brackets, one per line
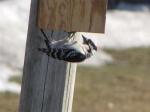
0,0,150,112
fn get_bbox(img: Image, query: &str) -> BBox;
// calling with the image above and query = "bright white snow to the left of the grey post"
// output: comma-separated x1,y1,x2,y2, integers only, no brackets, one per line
0,0,30,93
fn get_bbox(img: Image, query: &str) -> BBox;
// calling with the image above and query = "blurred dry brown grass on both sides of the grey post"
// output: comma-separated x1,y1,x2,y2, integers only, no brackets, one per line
0,48,150,112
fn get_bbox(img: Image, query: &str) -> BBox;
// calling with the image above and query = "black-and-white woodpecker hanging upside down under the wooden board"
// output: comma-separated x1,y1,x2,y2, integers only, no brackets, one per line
38,30,97,62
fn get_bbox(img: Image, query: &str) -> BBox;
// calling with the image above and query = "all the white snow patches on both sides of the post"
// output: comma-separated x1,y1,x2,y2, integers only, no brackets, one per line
0,0,150,93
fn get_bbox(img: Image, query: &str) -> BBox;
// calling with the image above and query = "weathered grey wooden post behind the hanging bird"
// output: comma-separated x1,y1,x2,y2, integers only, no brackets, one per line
19,0,76,112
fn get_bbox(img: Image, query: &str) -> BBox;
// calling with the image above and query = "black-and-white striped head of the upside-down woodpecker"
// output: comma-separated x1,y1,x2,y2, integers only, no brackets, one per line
82,35,97,52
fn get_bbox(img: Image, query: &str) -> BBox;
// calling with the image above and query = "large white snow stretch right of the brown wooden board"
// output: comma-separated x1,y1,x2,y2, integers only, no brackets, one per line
86,3,150,49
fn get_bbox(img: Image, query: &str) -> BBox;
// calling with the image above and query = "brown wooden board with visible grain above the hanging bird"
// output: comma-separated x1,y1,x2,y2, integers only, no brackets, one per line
37,0,107,33
